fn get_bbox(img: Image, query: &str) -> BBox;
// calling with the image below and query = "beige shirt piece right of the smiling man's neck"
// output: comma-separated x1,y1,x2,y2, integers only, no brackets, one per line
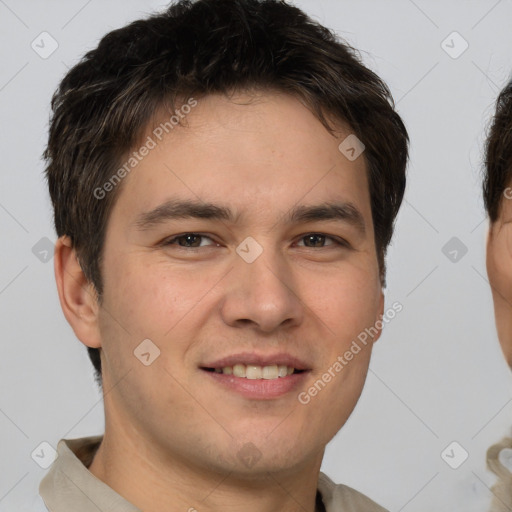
318,473,387,512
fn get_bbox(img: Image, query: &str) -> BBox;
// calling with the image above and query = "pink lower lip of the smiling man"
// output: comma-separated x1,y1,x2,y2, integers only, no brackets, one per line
201,370,309,400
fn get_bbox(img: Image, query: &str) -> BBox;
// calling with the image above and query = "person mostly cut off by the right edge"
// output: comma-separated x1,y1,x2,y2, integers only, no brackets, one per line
484,81,512,512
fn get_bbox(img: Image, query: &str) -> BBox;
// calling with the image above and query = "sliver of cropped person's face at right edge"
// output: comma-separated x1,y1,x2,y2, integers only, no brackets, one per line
487,189,512,368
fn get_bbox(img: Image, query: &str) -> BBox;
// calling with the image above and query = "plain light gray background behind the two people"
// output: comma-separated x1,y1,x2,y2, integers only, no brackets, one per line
0,0,512,512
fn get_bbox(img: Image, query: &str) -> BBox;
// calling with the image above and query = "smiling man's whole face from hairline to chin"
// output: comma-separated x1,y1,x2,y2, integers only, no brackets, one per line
92,93,383,477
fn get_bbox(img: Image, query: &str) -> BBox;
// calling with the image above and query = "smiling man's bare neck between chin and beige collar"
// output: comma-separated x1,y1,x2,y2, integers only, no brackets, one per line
89,412,323,512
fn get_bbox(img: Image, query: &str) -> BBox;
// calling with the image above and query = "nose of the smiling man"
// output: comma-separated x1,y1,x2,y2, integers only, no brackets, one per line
221,243,304,333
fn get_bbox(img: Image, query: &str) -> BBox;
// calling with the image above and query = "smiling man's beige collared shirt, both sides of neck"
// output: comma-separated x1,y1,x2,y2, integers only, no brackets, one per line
38,436,387,512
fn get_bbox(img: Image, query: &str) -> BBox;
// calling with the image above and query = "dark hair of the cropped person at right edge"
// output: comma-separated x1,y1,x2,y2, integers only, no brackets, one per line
483,80,512,222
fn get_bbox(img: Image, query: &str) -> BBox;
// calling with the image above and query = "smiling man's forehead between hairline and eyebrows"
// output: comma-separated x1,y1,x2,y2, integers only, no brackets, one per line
112,93,371,226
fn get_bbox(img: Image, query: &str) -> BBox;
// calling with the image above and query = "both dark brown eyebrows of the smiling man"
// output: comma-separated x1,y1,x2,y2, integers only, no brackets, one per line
134,199,366,235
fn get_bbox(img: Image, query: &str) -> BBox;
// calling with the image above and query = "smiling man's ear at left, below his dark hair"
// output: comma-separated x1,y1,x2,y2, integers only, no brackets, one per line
54,236,101,348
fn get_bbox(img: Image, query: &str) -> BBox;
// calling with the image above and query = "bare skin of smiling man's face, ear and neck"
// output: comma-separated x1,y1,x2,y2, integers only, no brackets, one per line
55,92,384,512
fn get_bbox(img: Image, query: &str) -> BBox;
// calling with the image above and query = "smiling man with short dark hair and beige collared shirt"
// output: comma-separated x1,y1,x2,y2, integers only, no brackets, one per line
40,0,408,512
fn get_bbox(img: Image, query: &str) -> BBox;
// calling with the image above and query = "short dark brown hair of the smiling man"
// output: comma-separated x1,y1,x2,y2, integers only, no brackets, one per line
43,0,409,385
